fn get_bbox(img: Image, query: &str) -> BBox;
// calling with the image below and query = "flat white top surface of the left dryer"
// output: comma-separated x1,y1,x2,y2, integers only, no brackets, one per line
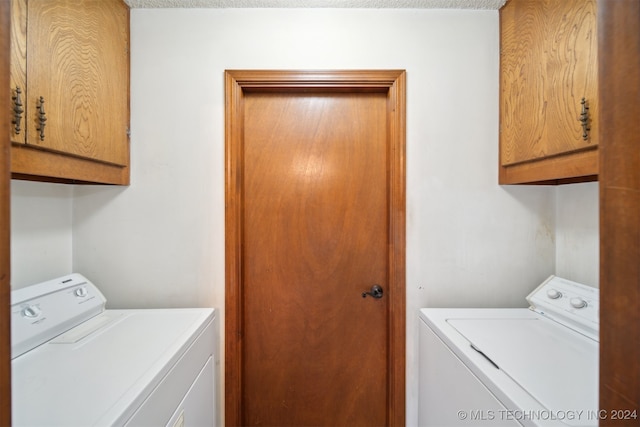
12,309,214,426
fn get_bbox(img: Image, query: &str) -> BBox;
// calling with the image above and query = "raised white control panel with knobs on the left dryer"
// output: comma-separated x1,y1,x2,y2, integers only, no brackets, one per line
11,273,107,359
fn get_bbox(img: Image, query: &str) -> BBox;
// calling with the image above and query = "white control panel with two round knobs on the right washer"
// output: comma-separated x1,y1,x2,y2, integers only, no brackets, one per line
527,276,600,340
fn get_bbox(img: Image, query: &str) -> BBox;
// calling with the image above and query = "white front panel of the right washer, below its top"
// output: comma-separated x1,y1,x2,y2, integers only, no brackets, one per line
418,321,521,427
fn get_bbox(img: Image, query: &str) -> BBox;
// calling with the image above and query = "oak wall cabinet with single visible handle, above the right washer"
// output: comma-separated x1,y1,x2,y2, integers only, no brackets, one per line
499,0,598,184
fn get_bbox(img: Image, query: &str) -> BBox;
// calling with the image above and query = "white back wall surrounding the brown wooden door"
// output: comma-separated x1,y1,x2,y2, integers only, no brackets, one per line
6,9,597,426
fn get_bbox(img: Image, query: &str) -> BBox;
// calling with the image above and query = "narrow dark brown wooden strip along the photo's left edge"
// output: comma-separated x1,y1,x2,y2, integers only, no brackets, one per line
0,0,11,426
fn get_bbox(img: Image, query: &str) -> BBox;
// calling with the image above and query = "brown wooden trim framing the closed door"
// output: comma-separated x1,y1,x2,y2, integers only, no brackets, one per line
225,70,406,426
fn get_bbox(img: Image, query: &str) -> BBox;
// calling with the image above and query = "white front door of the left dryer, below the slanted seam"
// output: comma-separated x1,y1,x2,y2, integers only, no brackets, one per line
166,358,216,427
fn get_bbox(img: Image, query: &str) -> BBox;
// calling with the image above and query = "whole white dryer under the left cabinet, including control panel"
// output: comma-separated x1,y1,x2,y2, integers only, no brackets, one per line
11,274,219,427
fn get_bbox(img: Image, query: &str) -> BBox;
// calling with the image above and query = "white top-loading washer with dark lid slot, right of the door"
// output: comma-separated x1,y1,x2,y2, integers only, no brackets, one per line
418,276,602,427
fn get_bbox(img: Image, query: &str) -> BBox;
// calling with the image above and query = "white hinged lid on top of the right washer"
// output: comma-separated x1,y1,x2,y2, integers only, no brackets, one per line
447,317,599,425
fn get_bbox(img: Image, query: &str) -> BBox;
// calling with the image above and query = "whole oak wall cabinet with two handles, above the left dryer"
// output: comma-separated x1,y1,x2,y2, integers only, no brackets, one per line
5,0,129,185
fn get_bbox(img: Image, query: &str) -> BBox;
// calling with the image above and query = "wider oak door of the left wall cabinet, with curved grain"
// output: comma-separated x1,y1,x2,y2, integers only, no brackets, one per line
26,0,129,166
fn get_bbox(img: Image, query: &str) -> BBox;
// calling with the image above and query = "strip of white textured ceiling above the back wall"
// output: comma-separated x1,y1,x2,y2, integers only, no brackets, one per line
125,0,506,10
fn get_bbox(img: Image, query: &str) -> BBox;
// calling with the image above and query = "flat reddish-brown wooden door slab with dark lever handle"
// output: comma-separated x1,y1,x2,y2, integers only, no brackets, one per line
243,92,389,426
